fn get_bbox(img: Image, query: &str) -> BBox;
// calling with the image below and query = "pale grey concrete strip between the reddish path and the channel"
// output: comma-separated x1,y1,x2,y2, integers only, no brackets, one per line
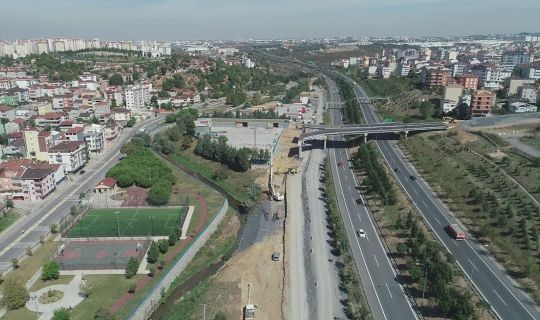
128,198,229,320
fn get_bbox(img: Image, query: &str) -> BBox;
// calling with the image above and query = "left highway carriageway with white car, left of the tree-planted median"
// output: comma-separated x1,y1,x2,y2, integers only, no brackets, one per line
327,79,417,320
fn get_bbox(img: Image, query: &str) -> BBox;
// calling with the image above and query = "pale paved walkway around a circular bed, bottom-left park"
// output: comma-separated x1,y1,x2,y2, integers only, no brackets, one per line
26,274,84,320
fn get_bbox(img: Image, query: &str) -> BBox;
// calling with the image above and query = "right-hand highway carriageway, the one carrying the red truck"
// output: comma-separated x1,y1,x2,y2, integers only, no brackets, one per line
350,80,540,320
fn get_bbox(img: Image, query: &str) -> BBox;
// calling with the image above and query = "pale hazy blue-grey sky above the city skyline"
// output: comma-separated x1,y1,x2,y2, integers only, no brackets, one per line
0,0,540,40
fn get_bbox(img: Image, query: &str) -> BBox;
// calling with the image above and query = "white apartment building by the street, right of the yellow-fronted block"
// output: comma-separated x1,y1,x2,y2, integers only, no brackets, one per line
48,141,88,172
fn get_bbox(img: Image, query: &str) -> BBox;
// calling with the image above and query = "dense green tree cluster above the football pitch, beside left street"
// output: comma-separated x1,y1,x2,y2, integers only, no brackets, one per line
106,133,176,205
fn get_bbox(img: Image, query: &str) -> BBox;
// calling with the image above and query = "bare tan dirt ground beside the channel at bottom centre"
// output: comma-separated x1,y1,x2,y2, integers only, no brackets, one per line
208,233,283,319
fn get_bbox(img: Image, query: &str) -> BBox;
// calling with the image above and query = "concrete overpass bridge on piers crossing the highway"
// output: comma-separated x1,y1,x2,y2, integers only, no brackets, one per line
298,122,448,152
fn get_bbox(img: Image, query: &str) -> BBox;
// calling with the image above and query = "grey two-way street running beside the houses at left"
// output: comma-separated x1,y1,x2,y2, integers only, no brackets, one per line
0,115,164,272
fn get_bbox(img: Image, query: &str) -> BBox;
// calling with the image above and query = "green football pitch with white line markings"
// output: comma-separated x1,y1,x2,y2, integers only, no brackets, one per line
66,207,188,238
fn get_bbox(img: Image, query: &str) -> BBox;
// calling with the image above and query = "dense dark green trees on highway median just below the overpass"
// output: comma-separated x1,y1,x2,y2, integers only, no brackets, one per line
353,144,396,205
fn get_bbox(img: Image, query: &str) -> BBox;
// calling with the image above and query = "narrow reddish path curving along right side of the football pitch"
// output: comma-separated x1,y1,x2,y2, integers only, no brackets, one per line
110,194,208,313
